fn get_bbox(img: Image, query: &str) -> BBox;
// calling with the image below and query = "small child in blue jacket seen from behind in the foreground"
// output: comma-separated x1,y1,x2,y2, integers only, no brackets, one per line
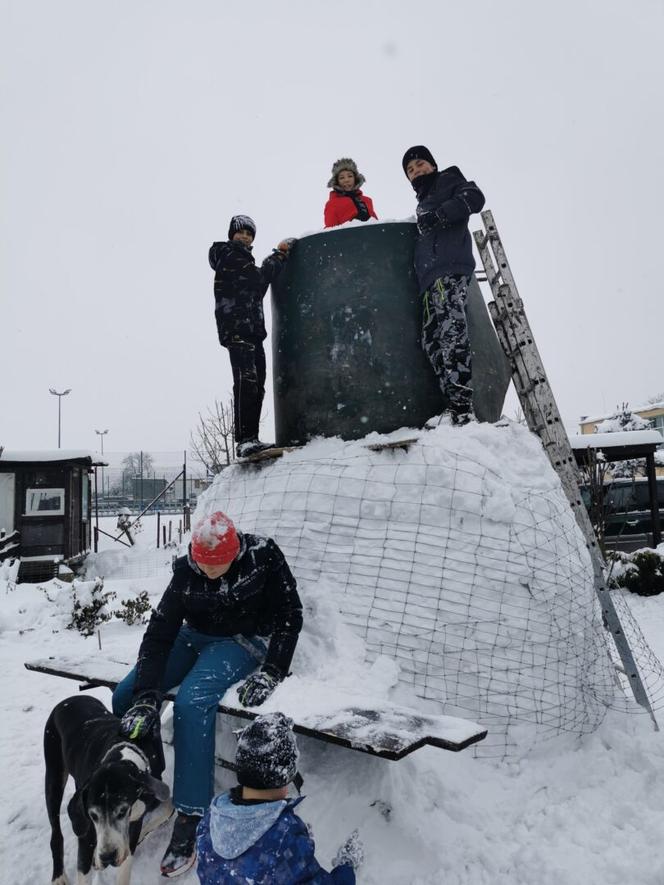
196,713,362,885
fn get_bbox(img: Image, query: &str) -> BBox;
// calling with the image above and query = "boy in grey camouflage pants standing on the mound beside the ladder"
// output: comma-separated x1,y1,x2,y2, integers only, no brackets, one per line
402,145,484,424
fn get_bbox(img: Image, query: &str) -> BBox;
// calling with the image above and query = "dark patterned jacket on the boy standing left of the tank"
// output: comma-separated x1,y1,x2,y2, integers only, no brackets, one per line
209,240,286,347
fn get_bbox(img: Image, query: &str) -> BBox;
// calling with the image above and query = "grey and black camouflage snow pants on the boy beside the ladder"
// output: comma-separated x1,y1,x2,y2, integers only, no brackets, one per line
422,275,473,415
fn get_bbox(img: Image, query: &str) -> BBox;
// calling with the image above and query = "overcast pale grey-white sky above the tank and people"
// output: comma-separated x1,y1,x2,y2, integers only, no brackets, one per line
0,0,664,451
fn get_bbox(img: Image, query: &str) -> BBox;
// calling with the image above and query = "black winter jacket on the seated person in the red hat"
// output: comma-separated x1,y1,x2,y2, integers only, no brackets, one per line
134,532,302,696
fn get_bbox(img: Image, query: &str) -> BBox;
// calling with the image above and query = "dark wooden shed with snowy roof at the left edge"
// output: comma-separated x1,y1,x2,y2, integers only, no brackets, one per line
0,449,94,581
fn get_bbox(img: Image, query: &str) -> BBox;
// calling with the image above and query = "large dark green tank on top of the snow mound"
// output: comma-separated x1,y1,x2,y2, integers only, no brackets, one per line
272,222,509,445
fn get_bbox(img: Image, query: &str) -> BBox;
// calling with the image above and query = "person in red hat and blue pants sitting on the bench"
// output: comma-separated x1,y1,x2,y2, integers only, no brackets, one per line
113,512,302,878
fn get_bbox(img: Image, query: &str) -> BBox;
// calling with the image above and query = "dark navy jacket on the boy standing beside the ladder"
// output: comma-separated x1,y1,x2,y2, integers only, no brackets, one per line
412,166,484,292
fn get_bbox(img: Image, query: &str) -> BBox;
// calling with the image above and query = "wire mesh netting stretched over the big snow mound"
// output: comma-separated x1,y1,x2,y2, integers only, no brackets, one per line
197,427,664,755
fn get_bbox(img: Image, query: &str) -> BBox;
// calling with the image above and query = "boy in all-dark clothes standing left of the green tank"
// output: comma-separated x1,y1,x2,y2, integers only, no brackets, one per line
209,215,295,458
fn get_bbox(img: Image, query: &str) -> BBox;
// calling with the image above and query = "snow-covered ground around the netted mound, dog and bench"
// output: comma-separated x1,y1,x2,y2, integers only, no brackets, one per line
0,427,664,885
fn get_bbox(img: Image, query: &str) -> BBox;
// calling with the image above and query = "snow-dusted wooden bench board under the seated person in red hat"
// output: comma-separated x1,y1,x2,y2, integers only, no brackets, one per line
25,655,486,759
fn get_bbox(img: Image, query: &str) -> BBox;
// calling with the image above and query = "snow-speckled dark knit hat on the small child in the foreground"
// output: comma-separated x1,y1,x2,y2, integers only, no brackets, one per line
235,713,298,790
